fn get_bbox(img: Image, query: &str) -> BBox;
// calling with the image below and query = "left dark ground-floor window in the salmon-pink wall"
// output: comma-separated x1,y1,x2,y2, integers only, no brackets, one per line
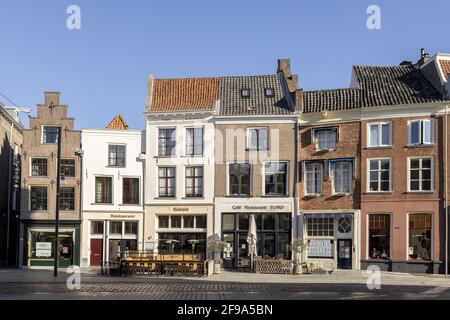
369,214,391,260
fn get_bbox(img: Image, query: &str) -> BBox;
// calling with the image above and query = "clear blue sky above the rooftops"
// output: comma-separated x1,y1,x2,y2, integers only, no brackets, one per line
0,0,450,129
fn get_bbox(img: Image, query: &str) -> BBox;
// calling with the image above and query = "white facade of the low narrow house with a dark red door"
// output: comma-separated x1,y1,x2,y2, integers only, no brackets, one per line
81,129,145,266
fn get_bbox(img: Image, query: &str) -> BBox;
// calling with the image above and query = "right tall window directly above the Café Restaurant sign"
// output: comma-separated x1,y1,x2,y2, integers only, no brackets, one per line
264,162,288,196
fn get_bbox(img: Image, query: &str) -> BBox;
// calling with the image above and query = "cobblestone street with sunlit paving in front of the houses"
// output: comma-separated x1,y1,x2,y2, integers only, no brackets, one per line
0,270,450,300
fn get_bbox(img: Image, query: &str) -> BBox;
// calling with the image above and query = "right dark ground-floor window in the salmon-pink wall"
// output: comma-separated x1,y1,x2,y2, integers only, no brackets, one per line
408,213,431,260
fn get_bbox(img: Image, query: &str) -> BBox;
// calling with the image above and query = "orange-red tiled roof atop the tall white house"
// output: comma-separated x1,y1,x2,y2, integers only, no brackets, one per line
150,78,219,112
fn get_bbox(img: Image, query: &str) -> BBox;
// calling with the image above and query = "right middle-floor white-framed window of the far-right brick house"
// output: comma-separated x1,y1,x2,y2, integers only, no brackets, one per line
408,158,434,191
